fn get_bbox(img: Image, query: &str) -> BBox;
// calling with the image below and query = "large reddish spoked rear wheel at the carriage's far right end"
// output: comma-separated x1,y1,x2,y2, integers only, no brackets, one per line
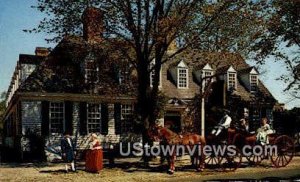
271,135,295,168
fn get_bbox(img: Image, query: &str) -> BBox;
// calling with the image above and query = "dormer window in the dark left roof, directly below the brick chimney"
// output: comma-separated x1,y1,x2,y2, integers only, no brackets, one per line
85,59,99,83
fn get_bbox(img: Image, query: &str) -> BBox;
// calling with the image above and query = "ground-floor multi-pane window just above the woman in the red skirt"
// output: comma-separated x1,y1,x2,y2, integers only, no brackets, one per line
87,104,101,133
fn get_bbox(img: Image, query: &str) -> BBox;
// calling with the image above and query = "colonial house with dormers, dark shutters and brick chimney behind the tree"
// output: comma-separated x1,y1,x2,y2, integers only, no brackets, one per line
4,8,276,160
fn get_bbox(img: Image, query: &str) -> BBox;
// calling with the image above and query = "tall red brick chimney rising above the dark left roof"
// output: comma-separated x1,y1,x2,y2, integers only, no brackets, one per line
82,7,104,43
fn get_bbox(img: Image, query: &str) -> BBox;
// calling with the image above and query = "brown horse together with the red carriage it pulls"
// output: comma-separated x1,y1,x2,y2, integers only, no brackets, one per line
149,123,295,173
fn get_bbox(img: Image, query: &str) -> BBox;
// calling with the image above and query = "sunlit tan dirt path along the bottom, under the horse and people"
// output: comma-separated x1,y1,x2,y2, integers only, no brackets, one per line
0,157,300,182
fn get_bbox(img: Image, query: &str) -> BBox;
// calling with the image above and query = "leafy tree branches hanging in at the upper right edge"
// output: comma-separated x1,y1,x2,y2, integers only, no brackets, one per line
253,0,300,98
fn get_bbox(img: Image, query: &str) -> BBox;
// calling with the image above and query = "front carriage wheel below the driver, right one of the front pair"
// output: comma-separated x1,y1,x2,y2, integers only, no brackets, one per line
221,148,242,172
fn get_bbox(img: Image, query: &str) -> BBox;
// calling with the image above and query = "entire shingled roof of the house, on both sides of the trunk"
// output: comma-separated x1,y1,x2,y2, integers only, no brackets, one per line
19,36,274,104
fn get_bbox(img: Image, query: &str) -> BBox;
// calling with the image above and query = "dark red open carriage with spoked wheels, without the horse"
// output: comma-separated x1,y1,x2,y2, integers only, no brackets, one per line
205,127,295,171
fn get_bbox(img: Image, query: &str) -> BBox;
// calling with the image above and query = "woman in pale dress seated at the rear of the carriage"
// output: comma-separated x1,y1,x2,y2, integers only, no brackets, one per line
256,118,274,145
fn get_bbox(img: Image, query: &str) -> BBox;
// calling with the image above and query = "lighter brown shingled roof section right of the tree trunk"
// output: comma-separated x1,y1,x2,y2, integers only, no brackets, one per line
162,50,275,101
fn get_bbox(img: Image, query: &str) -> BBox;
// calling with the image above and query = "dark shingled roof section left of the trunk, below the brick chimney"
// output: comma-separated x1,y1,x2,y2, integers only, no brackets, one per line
19,36,136,96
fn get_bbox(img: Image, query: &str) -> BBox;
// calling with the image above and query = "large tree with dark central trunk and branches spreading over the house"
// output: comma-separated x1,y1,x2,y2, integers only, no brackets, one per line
27,0,272,161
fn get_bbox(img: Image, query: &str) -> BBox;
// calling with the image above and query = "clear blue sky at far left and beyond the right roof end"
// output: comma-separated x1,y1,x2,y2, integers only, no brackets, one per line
0,0,300,109
